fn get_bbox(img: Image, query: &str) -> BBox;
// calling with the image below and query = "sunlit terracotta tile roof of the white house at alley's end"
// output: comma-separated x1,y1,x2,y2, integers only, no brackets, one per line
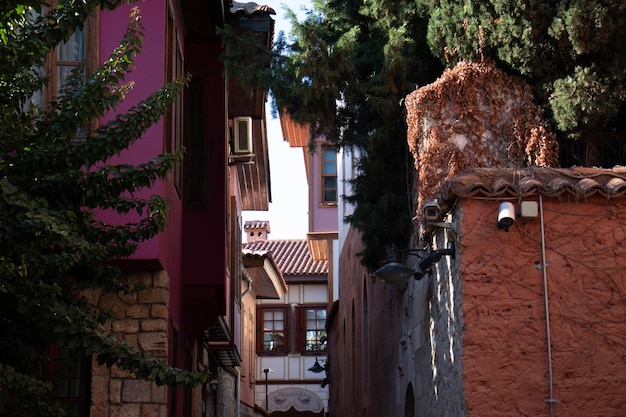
242,239,328,276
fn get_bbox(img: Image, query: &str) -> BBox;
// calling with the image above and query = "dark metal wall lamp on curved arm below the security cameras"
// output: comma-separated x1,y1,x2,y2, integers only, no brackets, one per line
374,245,455,284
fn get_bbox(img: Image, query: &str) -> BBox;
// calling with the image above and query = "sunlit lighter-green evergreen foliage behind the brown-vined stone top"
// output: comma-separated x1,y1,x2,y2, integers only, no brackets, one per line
419,0,626,166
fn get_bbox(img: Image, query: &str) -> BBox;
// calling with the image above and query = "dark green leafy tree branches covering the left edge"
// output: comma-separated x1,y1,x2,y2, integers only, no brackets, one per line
0,0,204,416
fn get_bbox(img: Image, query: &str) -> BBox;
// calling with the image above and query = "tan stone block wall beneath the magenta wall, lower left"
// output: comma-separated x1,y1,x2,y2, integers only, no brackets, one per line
86,270,169,417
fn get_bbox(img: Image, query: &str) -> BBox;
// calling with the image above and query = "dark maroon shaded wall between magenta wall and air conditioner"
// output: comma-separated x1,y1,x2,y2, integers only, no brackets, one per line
182,40,229,340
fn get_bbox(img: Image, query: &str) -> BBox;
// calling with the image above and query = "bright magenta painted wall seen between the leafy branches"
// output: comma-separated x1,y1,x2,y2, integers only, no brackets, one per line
99,0,184,321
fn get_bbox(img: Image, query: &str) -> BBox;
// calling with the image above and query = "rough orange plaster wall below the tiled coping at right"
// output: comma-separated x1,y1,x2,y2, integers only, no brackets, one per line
459,196,626,417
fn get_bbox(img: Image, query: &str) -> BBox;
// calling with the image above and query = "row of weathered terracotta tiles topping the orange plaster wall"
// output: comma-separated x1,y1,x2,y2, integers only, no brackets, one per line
439,166,626,201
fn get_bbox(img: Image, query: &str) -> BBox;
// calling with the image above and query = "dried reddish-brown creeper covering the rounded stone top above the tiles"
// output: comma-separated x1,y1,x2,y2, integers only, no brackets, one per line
406,61,559,216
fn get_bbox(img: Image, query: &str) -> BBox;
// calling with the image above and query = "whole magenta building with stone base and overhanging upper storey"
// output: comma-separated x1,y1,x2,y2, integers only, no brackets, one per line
80,0,274,417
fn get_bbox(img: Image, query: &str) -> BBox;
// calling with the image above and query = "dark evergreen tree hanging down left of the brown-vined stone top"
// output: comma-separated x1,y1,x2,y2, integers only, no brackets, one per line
271,0,442,269
